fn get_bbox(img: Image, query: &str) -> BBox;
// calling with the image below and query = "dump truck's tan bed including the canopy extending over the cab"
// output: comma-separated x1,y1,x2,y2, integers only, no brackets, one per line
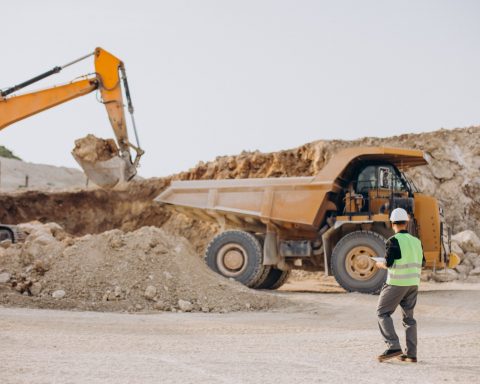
156,147,426,232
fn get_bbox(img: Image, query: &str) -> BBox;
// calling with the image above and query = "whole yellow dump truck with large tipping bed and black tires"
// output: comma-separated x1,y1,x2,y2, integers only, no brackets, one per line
156,147,458,293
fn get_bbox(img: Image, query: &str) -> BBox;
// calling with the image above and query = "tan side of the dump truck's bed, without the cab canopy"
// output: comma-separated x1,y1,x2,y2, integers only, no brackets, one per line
157,177,332,230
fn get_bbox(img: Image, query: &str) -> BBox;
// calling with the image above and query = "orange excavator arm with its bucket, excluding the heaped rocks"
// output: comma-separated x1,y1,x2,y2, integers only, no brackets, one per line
0,48,144,188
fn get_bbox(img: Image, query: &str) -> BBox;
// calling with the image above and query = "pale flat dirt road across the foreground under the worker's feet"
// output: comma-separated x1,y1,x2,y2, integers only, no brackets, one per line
0,284,480,384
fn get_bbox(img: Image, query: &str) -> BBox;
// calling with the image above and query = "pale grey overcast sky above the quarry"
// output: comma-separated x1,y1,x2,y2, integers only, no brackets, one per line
0,0,480,177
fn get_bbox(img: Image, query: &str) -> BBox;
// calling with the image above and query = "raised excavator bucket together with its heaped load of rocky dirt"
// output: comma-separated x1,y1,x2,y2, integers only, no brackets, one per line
72,135,136,189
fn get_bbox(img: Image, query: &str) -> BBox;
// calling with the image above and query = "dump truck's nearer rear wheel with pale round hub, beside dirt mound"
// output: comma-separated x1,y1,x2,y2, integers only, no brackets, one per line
205,230,270,288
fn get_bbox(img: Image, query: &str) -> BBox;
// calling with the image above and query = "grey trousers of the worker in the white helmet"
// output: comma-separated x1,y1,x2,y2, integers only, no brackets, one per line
377,284,418,357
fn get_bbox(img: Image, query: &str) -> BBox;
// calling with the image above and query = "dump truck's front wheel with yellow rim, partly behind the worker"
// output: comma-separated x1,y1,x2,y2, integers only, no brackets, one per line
331,231,387,293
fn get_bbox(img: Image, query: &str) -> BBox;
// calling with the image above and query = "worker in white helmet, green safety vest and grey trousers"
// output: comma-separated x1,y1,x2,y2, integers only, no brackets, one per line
376,208,425,363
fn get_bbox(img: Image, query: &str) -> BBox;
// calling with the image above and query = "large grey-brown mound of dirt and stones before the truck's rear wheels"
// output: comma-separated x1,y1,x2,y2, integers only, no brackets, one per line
0,223,283,312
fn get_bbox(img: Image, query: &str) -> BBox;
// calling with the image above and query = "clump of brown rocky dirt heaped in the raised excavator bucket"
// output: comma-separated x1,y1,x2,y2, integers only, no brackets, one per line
72,134,118,163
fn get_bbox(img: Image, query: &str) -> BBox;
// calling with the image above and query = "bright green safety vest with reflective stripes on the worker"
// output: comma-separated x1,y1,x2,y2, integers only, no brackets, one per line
387,233,423,287
